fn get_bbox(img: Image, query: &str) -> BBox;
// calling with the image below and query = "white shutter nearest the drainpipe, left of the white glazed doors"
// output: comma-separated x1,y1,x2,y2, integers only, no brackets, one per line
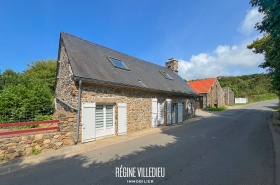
82,103,96,143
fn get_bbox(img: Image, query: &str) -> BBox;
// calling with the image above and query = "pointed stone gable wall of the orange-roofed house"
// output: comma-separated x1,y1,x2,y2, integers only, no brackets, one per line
207,79,225,107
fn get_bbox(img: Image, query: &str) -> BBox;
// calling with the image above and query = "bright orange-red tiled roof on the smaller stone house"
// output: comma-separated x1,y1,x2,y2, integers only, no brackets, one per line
188,78,216,94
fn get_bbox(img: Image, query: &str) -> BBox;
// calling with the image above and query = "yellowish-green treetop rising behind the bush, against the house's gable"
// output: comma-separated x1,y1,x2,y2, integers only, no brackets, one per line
24,59,56,93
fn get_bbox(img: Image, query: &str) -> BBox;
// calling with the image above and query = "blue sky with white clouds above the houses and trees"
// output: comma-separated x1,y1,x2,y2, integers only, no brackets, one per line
0,0,265,80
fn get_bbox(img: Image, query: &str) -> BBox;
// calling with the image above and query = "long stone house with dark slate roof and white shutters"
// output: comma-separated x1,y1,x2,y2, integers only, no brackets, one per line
55,32,198,142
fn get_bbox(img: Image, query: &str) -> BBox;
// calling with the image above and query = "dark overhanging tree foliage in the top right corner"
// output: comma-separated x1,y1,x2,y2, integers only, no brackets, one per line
247,0,280,93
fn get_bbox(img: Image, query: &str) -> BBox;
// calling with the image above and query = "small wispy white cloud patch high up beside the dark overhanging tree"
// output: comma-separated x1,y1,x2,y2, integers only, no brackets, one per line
237,8,263,36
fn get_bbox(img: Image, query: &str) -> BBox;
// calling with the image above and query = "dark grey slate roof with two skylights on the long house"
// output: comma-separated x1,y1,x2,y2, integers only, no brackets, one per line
60,32,197,95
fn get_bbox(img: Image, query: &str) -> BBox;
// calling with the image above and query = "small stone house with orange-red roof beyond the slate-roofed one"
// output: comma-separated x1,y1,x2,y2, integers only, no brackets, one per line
187,78,226,109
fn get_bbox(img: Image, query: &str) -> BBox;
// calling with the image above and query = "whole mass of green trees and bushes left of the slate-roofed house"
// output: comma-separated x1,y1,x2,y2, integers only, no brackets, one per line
0,60,56,127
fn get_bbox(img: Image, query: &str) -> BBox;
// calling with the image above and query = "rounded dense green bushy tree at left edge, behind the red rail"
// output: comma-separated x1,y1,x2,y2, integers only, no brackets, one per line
0,75,53,123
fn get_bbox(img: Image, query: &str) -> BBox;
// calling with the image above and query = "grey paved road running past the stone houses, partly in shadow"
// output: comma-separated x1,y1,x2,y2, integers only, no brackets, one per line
0,100,277,185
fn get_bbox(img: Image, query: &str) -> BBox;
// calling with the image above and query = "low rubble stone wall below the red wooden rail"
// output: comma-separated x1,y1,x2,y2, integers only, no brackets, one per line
0,113,77,162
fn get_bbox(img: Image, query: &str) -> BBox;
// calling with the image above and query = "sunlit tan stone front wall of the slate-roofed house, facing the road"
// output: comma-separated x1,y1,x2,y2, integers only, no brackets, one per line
77,83,195,134
